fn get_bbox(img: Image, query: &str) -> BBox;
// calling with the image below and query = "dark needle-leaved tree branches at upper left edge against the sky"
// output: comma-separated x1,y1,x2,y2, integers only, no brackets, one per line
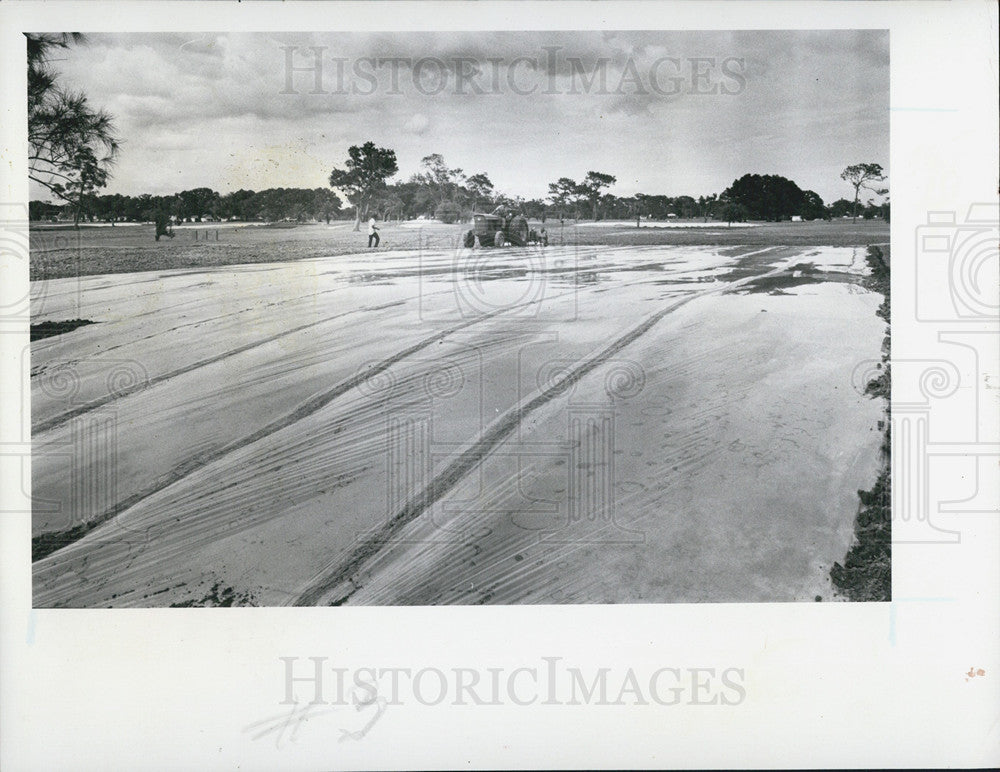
25,33,119,225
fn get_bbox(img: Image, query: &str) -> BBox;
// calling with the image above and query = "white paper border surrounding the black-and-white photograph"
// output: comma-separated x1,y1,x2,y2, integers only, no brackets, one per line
0,0,1000,770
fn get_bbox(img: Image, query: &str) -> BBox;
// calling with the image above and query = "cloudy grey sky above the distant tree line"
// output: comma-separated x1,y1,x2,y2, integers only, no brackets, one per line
32,31,889,201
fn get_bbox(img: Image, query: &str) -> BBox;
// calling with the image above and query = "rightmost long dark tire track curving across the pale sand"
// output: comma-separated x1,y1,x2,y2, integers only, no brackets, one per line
292,260,785,606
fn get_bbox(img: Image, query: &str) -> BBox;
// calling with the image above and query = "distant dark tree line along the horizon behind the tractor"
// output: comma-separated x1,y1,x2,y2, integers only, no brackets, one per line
29,167,889,228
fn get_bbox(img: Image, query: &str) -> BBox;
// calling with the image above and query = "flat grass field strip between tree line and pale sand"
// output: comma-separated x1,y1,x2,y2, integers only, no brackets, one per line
31,220,889,281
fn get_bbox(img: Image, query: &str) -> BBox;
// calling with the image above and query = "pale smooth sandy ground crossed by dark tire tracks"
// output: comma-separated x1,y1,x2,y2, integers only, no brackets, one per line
31,246,883,607
